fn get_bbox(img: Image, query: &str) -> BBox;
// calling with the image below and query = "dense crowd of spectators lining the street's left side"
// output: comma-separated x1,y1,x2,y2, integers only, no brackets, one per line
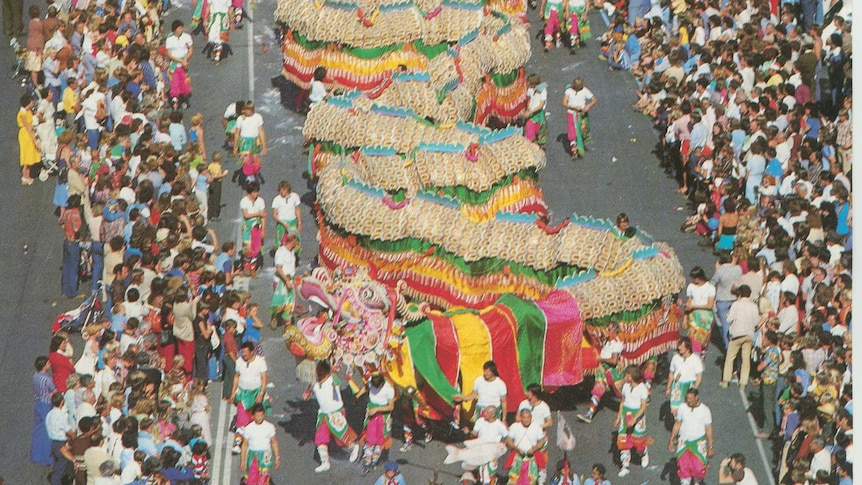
18,0,286,485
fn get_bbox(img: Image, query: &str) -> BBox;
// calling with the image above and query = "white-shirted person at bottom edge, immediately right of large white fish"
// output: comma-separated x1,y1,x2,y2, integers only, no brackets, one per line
506,409,548,483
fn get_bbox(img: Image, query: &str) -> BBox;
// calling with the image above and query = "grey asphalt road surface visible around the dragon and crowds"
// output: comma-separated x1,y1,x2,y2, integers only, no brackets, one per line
0,0,769,484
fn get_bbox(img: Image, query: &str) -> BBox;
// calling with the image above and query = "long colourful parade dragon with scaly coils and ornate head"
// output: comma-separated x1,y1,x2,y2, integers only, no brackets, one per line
276,0,684,409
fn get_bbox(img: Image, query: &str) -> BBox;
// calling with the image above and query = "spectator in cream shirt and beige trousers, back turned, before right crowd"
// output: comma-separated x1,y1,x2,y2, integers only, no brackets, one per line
719,285,760,389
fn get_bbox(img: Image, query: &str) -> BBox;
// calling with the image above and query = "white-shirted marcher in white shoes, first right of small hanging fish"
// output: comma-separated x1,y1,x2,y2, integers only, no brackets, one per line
614,365,649,477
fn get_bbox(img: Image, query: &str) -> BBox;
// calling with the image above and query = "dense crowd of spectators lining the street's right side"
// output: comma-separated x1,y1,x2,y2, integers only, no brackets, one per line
595,0,853,485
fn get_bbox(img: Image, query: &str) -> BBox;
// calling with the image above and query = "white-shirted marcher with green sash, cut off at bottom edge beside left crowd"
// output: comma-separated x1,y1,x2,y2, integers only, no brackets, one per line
239,404,281,483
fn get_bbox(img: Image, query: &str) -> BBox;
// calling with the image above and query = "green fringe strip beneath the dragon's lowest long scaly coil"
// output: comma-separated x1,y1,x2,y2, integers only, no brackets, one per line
324,222,584,287
